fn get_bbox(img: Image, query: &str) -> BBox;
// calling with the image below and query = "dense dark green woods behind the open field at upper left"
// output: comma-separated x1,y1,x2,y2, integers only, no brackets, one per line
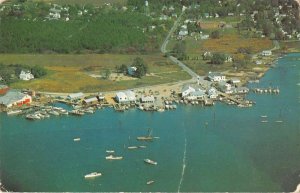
0,12,149,53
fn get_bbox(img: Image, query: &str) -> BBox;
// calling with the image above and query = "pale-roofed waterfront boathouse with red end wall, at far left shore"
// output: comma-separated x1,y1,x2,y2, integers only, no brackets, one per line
0,90,32,108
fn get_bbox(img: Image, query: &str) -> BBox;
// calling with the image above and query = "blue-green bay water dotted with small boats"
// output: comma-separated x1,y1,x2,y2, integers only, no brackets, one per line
0,53,300,191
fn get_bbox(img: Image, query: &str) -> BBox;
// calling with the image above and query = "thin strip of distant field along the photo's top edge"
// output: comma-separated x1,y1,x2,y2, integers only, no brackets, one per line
31,0,127,5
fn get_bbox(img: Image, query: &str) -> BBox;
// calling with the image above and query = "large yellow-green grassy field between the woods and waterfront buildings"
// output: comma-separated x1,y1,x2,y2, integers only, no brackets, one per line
0,54,190,92
